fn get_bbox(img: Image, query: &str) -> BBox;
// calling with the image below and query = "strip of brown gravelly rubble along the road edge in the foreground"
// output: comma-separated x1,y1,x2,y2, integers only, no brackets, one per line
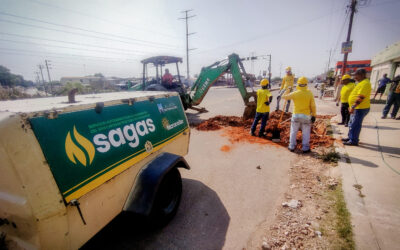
259,156,338,249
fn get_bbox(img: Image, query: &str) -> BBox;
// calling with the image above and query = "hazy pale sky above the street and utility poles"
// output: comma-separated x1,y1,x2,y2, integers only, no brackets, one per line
0,0,400,80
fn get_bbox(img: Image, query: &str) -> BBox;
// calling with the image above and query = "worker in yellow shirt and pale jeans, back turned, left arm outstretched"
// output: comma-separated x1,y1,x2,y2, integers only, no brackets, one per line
282,76,317,153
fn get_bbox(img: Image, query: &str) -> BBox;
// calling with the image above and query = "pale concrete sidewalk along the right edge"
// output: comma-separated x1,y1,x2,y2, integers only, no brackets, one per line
332,106,400,249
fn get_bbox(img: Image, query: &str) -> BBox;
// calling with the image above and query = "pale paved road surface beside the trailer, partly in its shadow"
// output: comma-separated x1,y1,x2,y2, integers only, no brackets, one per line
85,88,296,249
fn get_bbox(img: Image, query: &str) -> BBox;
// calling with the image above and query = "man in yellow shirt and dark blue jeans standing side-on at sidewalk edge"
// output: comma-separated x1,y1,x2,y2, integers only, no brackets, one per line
342,69,371,146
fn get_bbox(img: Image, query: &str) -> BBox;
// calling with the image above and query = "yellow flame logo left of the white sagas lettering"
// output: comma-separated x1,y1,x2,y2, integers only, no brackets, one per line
65,126,96,167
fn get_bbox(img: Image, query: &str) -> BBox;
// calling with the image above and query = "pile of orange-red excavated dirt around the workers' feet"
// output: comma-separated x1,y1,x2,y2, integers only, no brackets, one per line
196,110,334,149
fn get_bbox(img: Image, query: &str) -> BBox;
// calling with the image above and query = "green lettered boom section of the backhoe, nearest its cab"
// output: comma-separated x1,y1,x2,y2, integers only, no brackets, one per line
192,65,228,105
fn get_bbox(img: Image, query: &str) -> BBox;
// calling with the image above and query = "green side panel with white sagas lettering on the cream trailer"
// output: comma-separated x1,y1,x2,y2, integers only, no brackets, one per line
31,96,188,198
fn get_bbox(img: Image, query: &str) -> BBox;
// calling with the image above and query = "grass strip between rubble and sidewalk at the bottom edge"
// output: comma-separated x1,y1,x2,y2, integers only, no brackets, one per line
320,182,355,250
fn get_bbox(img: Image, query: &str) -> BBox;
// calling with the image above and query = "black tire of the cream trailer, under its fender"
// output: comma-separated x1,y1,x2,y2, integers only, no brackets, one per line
149,168,182,227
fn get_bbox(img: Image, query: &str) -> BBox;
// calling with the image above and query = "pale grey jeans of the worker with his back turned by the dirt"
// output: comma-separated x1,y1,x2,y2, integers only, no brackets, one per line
289,114,311,151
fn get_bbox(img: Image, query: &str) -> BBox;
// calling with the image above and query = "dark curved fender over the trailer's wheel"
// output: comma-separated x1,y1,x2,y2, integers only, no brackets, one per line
123,153,190,215
